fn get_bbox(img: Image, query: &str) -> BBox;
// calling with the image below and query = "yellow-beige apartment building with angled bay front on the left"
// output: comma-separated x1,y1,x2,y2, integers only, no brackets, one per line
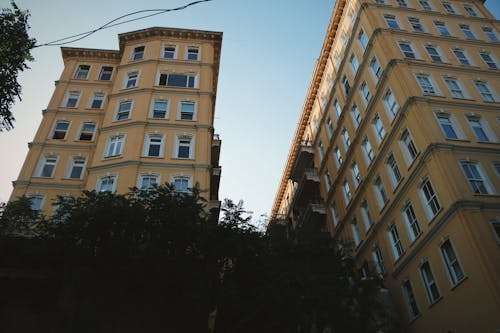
11,28,222,218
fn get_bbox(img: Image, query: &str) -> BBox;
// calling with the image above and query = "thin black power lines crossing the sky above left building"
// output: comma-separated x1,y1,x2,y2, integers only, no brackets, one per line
34,0,212,47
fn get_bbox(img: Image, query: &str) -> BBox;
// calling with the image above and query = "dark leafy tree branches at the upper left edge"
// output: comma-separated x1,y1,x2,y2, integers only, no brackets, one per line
0,1,36,131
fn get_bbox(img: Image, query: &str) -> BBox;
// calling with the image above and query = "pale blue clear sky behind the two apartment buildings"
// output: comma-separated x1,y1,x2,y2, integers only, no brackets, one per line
0,0,500,218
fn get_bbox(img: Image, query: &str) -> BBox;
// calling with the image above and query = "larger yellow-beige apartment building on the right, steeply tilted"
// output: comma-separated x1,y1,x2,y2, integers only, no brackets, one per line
271,0,500,333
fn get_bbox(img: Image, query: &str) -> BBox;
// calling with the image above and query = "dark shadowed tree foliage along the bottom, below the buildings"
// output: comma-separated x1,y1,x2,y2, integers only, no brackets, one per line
0,185,386,333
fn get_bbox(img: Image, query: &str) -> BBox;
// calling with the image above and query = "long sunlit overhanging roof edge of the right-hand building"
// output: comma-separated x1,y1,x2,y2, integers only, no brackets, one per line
271,0,347,219
